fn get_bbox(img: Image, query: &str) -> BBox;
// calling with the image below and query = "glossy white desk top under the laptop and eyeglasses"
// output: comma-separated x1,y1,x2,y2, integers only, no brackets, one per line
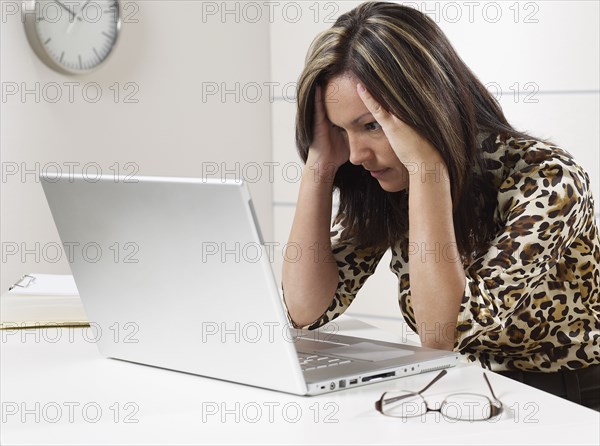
0,316,600,445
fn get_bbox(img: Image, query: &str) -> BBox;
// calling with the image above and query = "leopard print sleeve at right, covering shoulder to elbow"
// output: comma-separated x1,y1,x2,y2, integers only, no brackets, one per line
454,148,593,351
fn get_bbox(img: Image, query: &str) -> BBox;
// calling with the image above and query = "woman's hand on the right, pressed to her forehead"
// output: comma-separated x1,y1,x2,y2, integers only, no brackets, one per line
356,84,441,166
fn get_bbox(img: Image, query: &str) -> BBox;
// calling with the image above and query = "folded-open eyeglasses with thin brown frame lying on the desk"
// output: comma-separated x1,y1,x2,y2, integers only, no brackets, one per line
375,370,502,421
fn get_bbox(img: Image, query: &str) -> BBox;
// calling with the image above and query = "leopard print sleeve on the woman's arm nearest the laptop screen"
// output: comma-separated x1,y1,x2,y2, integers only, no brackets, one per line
284,218,385,330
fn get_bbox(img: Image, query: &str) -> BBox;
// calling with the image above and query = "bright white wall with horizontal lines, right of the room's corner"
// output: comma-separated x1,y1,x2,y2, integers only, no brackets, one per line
271,1,600,318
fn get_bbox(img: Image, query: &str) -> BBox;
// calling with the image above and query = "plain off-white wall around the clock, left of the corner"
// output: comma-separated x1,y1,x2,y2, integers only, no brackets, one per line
0,0,272,290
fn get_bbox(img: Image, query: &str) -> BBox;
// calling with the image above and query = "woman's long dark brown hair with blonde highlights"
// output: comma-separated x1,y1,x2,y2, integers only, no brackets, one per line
296,2,530,261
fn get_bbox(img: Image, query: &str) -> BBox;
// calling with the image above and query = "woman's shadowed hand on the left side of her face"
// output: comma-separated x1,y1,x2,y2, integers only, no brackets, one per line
306,86,350,180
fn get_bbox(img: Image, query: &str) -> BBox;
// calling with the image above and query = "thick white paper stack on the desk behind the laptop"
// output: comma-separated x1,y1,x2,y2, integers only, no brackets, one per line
0,274,89,329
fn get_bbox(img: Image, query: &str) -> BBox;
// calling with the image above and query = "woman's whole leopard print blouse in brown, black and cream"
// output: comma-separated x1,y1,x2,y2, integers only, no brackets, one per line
292,134,600,372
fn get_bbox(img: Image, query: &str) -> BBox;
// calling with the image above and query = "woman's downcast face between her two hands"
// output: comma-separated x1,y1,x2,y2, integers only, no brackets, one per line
323,74,408,192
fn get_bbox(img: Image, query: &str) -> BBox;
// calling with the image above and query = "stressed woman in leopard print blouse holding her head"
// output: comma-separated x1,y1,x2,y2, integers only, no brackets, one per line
283,2,600,407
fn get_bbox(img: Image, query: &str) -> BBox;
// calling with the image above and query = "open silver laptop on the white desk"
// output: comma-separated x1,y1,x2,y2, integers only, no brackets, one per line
41,175,458,395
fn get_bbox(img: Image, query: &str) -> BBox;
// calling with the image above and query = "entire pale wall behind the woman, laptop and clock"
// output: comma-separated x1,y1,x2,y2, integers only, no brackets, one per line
0,0,600,306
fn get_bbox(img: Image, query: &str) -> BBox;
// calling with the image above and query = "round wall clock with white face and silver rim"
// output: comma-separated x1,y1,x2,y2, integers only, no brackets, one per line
25,0,121,74
